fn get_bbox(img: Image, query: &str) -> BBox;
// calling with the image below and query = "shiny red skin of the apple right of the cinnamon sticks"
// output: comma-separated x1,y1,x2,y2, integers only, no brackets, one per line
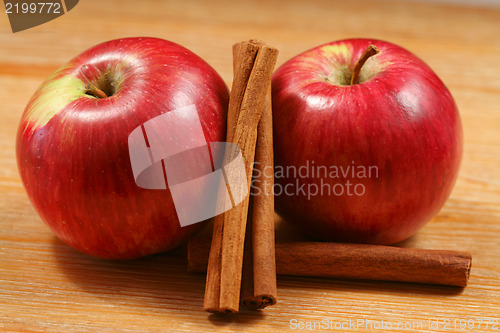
272,39,462,244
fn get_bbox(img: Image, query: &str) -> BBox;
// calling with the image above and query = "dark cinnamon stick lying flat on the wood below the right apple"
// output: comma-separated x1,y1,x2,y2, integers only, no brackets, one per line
188,239,472,287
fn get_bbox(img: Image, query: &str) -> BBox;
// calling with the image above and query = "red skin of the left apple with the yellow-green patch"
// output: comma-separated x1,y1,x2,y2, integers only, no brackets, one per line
17,37,229,259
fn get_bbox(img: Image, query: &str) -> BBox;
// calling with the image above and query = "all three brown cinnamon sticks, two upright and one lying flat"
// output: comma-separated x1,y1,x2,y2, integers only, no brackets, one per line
188,40,471,313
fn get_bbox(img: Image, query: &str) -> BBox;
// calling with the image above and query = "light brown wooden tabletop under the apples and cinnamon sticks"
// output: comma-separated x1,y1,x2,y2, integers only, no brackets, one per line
0,0,500,332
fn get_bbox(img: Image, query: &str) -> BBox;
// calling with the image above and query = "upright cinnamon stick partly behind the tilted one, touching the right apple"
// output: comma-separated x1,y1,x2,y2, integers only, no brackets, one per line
233,40,277,309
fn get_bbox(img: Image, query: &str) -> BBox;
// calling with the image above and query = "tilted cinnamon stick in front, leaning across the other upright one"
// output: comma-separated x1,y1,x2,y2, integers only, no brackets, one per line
204,42,278,313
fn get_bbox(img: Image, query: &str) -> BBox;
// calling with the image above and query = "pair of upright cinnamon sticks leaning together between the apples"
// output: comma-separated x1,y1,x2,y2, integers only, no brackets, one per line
204,41,278,313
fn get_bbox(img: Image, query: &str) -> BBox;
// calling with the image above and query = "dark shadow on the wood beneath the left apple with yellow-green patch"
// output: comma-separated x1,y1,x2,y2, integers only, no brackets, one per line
51,236,265,327
